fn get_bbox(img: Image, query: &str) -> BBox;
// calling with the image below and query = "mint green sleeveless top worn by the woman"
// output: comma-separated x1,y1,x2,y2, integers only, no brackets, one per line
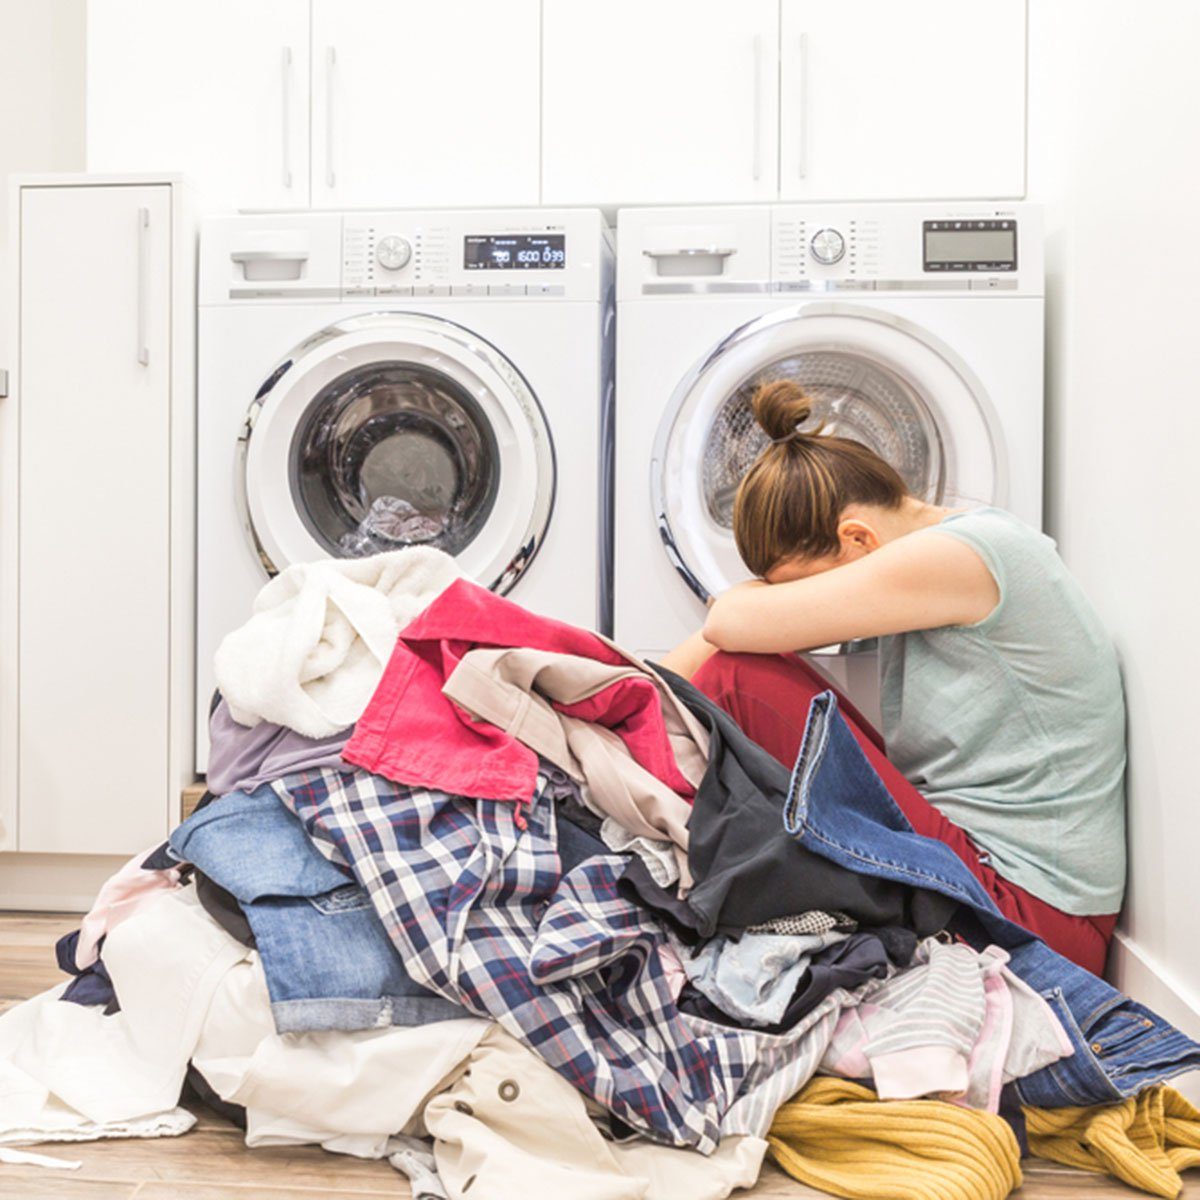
881,508,1126,916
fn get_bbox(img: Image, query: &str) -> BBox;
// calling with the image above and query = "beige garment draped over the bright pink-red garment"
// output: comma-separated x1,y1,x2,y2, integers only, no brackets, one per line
442,647,708,888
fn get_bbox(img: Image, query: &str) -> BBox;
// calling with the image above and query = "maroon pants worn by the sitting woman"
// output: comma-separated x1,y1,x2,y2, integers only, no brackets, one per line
692,653,1117,974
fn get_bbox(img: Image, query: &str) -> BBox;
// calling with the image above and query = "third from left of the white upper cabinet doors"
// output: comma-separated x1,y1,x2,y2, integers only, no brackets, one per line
542,0,779,204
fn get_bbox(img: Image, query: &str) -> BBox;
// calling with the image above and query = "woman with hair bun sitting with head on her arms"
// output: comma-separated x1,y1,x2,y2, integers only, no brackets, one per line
665,380,1124,973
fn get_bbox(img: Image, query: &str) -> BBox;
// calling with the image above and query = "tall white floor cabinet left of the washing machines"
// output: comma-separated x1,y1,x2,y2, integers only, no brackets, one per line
0,176,196,857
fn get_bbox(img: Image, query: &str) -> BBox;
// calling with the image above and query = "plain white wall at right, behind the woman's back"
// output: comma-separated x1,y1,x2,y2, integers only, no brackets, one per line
1030,0,1200,1036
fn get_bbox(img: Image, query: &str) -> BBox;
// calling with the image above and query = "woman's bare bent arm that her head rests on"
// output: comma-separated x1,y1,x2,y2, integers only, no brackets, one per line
703,529,1000,654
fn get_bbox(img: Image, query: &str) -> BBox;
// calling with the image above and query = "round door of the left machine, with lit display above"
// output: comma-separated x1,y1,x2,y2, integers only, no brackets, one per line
242,313,556,593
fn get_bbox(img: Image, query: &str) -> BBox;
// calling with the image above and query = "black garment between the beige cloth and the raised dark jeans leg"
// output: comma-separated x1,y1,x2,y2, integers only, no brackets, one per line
637,667,956,937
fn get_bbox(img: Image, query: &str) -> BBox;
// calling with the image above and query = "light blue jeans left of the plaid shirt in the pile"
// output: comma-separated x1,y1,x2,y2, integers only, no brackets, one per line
170,785,470,1033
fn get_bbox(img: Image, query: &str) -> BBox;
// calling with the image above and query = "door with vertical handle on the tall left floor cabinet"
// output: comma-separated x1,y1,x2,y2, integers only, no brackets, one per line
17,186,172,854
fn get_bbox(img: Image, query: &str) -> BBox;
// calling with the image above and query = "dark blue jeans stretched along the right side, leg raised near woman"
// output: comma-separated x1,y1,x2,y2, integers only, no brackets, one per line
784,691,1200,1108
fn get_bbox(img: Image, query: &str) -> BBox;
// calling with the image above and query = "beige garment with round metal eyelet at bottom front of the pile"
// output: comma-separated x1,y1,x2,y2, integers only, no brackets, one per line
425,1026,766,1200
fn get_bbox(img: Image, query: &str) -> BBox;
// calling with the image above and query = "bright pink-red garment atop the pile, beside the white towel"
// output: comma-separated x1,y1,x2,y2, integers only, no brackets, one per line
342,580,695,802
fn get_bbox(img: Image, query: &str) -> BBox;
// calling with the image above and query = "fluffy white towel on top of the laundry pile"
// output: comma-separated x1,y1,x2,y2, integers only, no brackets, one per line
215,546,462,738
